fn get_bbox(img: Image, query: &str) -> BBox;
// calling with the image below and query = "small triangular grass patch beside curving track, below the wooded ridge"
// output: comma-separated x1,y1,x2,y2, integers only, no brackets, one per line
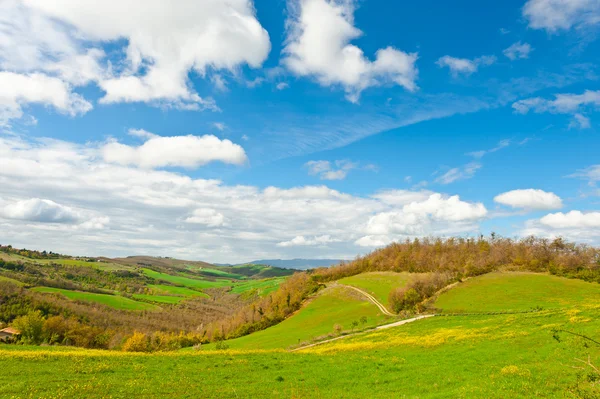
338,272,418,306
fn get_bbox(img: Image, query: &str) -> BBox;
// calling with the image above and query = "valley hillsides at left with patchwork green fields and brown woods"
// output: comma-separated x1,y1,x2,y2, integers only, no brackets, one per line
0,246,293,348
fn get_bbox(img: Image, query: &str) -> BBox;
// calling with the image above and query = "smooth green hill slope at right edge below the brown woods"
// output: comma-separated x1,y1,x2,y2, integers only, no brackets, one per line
434,273,600,312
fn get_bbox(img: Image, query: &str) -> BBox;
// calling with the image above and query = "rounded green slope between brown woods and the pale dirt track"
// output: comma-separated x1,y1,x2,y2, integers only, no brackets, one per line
209,286,388,349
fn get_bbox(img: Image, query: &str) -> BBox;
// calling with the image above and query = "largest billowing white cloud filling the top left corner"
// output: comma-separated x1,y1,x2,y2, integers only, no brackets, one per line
0,0,271,118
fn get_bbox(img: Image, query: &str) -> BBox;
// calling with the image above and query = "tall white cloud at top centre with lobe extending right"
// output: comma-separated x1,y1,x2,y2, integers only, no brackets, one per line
282,0,418,102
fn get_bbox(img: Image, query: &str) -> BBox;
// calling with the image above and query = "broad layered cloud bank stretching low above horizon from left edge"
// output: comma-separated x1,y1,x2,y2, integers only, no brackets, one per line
0,136,492,262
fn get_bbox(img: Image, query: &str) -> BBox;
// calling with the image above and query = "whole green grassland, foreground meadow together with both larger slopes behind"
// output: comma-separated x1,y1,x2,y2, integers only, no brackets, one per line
7,273,600,399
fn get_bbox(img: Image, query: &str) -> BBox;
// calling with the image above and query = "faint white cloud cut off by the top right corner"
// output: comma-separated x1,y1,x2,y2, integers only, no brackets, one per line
523,0,600,33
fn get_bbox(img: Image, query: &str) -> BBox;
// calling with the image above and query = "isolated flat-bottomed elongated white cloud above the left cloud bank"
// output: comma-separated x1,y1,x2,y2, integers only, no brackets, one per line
102,135,248,168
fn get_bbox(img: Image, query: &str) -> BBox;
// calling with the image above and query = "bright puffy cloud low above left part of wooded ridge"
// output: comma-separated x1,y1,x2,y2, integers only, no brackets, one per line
355,193,487,246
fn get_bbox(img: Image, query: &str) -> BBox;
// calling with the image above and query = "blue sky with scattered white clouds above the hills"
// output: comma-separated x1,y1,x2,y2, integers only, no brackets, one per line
0,0,600,262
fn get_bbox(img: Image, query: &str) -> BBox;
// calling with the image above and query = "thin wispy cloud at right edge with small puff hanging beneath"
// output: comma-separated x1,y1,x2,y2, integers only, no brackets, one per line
512,90,600,129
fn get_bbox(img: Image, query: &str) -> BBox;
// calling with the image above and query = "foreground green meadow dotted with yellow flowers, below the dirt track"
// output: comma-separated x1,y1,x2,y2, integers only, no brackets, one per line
0,307,600,399
